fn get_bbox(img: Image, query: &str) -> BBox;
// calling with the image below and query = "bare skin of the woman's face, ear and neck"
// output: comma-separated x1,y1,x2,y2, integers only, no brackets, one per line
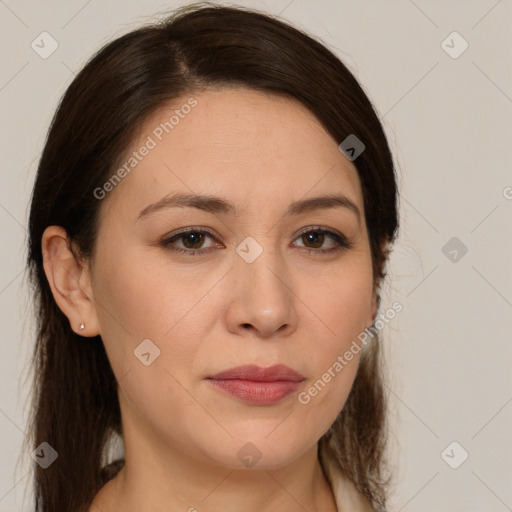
42,87,377,512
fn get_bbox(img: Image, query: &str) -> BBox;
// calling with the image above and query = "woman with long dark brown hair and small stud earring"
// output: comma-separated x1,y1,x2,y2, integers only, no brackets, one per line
28,4,398,512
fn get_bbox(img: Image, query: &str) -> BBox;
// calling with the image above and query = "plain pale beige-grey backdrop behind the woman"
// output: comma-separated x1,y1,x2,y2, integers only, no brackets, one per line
0,0,512,512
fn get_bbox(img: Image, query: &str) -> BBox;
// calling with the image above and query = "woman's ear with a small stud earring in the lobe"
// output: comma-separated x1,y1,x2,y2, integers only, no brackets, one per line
41,226,99,337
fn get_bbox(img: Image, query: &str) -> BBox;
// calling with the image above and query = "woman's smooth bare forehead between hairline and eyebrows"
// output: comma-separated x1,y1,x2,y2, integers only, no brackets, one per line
105,87,362,222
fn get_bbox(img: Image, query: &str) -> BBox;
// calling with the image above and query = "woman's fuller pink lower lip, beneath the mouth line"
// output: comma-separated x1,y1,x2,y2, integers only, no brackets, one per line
209,379,302,405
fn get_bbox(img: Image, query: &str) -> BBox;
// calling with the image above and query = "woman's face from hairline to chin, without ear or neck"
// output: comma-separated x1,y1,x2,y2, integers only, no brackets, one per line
84,88,375,468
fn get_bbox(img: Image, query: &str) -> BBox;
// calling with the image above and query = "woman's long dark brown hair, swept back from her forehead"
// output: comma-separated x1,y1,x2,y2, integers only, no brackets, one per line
27,2,398,512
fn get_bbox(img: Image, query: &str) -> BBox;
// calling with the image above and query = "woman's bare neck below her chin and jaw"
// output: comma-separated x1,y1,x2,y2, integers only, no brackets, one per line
91,433,337,512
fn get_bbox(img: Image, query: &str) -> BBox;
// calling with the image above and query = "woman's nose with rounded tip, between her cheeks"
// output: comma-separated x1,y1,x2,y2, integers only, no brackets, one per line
226,244,299,339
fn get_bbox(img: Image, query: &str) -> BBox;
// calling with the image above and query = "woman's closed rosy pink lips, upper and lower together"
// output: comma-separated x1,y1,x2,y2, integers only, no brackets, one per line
207,364,305,405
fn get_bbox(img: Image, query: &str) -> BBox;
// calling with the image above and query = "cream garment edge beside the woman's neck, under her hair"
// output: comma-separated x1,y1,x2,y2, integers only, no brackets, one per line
319,442,374,512
